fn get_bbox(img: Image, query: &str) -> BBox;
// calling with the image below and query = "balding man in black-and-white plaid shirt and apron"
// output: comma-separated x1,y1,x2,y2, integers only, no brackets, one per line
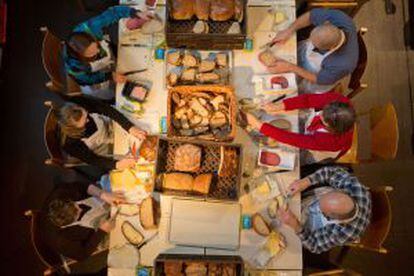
278,167,371,254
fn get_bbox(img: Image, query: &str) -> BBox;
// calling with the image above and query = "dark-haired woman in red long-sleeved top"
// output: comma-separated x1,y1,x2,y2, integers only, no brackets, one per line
246,91,356,164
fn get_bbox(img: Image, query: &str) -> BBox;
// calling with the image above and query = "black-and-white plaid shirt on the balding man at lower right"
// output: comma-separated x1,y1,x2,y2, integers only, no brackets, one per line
298,167,371,253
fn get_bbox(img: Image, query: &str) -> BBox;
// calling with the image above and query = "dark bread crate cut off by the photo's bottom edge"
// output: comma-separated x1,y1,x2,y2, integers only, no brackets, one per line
154,254,244,276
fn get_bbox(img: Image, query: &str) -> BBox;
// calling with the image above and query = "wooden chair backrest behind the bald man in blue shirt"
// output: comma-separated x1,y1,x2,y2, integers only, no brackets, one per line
348,28,368,98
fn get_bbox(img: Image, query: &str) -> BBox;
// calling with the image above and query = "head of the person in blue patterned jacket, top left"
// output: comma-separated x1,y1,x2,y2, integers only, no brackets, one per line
68,32,100,60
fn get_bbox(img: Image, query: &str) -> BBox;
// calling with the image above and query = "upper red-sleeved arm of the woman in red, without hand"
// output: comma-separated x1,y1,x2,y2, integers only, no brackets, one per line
283,91,349,110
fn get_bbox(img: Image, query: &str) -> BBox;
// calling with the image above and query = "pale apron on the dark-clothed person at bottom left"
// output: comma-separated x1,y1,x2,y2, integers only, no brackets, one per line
62,197,110,230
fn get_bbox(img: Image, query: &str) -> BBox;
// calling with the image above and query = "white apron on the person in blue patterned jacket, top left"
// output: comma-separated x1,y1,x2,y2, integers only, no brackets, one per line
80,40,115,100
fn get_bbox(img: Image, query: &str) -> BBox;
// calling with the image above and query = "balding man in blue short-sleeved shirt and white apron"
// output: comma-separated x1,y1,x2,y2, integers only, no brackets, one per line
268,9,359,93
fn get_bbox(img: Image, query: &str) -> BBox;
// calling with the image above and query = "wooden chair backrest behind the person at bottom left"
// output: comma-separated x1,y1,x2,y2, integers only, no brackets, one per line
25,210,62,275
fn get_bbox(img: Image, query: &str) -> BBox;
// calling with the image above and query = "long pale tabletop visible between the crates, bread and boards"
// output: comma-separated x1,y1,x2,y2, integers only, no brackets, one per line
108,0,302,275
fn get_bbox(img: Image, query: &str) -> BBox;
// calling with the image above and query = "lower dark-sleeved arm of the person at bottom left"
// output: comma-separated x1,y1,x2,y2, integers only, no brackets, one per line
57,226,106,261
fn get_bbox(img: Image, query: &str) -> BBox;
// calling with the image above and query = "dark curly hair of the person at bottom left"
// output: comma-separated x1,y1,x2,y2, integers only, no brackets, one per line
48,199,78,227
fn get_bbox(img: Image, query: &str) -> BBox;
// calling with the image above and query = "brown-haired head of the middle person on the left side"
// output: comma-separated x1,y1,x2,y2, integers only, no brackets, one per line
57,103,88,138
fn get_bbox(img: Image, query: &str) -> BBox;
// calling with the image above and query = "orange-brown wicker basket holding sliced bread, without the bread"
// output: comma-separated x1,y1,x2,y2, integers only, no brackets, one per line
167,85,237,142
